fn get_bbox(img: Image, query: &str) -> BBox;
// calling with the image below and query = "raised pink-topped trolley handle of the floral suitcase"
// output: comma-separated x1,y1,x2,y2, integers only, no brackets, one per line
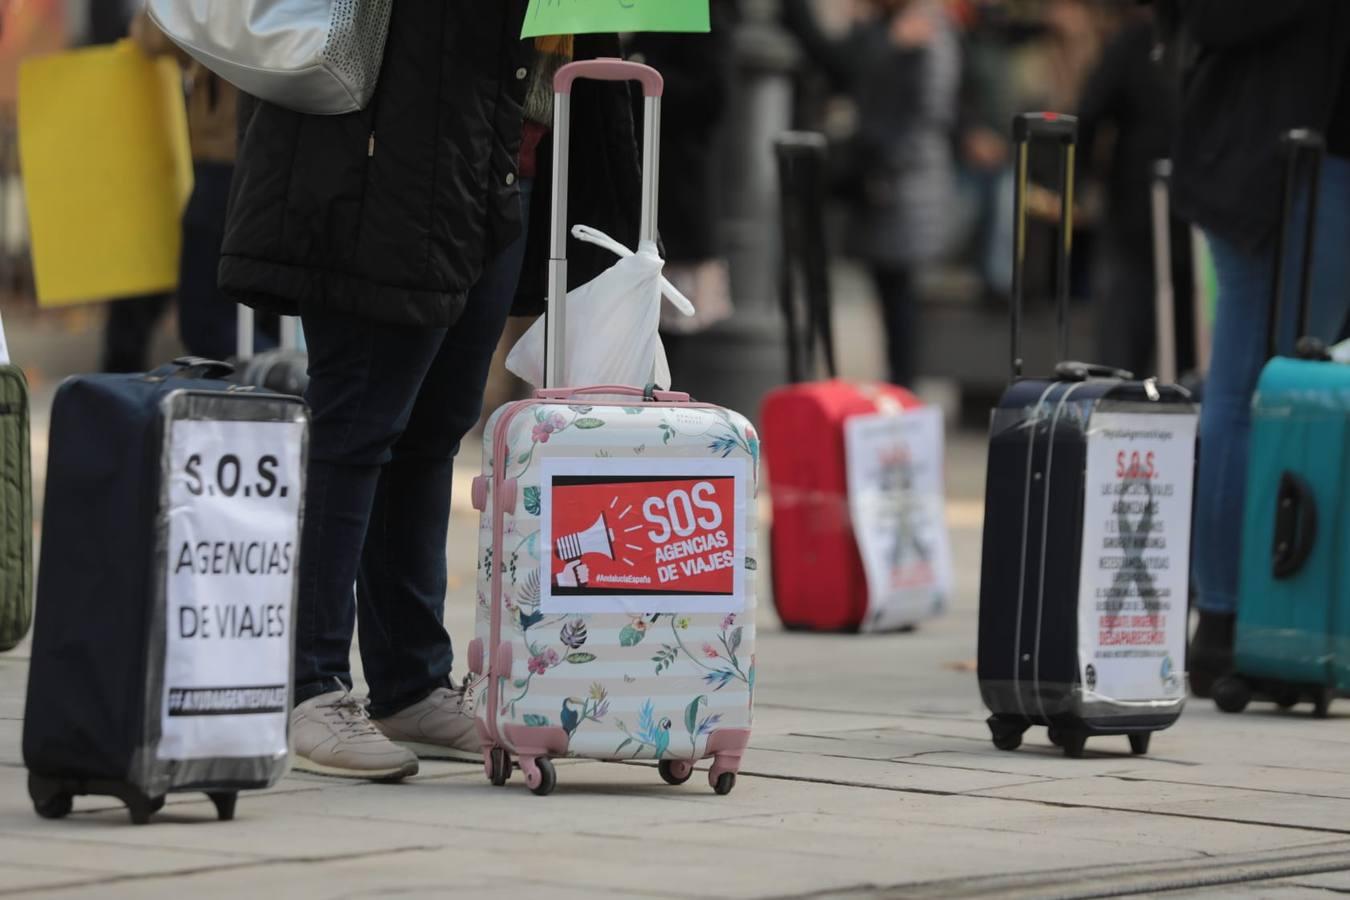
544,59,666,387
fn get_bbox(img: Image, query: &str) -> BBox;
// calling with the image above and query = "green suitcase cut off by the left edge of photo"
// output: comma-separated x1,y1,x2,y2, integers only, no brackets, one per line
0,353,32,650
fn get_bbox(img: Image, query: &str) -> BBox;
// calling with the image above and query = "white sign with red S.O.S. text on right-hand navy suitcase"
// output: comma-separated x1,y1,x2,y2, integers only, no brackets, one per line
1079,413,1197,700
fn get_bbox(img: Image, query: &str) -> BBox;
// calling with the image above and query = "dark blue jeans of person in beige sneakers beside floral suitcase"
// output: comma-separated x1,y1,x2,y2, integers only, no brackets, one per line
296,181,532,718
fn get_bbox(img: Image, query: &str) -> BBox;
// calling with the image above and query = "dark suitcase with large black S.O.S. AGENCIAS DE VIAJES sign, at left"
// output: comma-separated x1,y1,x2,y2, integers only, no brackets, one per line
23,359,308,823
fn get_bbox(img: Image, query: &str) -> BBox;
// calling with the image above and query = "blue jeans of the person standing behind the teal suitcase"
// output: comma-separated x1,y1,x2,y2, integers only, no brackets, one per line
1193,157,1350,613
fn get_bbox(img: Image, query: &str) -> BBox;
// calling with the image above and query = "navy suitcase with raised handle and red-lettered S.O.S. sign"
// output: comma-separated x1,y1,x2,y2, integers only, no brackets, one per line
979,113,1197,757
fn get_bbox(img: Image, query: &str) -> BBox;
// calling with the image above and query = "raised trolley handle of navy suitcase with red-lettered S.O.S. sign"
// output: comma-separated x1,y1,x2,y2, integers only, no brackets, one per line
1011,112,1079,379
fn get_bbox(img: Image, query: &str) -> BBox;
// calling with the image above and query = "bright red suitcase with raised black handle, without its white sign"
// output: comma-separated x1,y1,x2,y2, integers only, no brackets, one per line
760,134,945,631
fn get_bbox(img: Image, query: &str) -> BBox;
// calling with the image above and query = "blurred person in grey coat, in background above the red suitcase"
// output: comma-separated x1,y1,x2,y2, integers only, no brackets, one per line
786,0,961,386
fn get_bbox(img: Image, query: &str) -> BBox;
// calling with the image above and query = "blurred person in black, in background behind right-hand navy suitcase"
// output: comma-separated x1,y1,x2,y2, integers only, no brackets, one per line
1077,7,1195,376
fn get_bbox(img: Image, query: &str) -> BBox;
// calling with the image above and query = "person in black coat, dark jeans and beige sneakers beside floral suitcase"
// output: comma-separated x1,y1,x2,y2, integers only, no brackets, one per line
220,0,640,780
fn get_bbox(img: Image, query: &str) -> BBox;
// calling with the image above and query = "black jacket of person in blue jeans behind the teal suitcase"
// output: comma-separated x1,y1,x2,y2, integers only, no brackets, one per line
1173,0,1350,252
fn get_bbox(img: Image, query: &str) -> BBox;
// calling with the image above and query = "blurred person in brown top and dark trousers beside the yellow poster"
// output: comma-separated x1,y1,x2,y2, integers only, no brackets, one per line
131,9,277,359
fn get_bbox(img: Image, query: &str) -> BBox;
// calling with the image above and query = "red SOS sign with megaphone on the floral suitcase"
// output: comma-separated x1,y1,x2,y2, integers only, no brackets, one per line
540,459,749,614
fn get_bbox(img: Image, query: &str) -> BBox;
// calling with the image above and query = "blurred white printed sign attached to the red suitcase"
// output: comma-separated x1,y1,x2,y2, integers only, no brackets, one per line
844,407,952,631
